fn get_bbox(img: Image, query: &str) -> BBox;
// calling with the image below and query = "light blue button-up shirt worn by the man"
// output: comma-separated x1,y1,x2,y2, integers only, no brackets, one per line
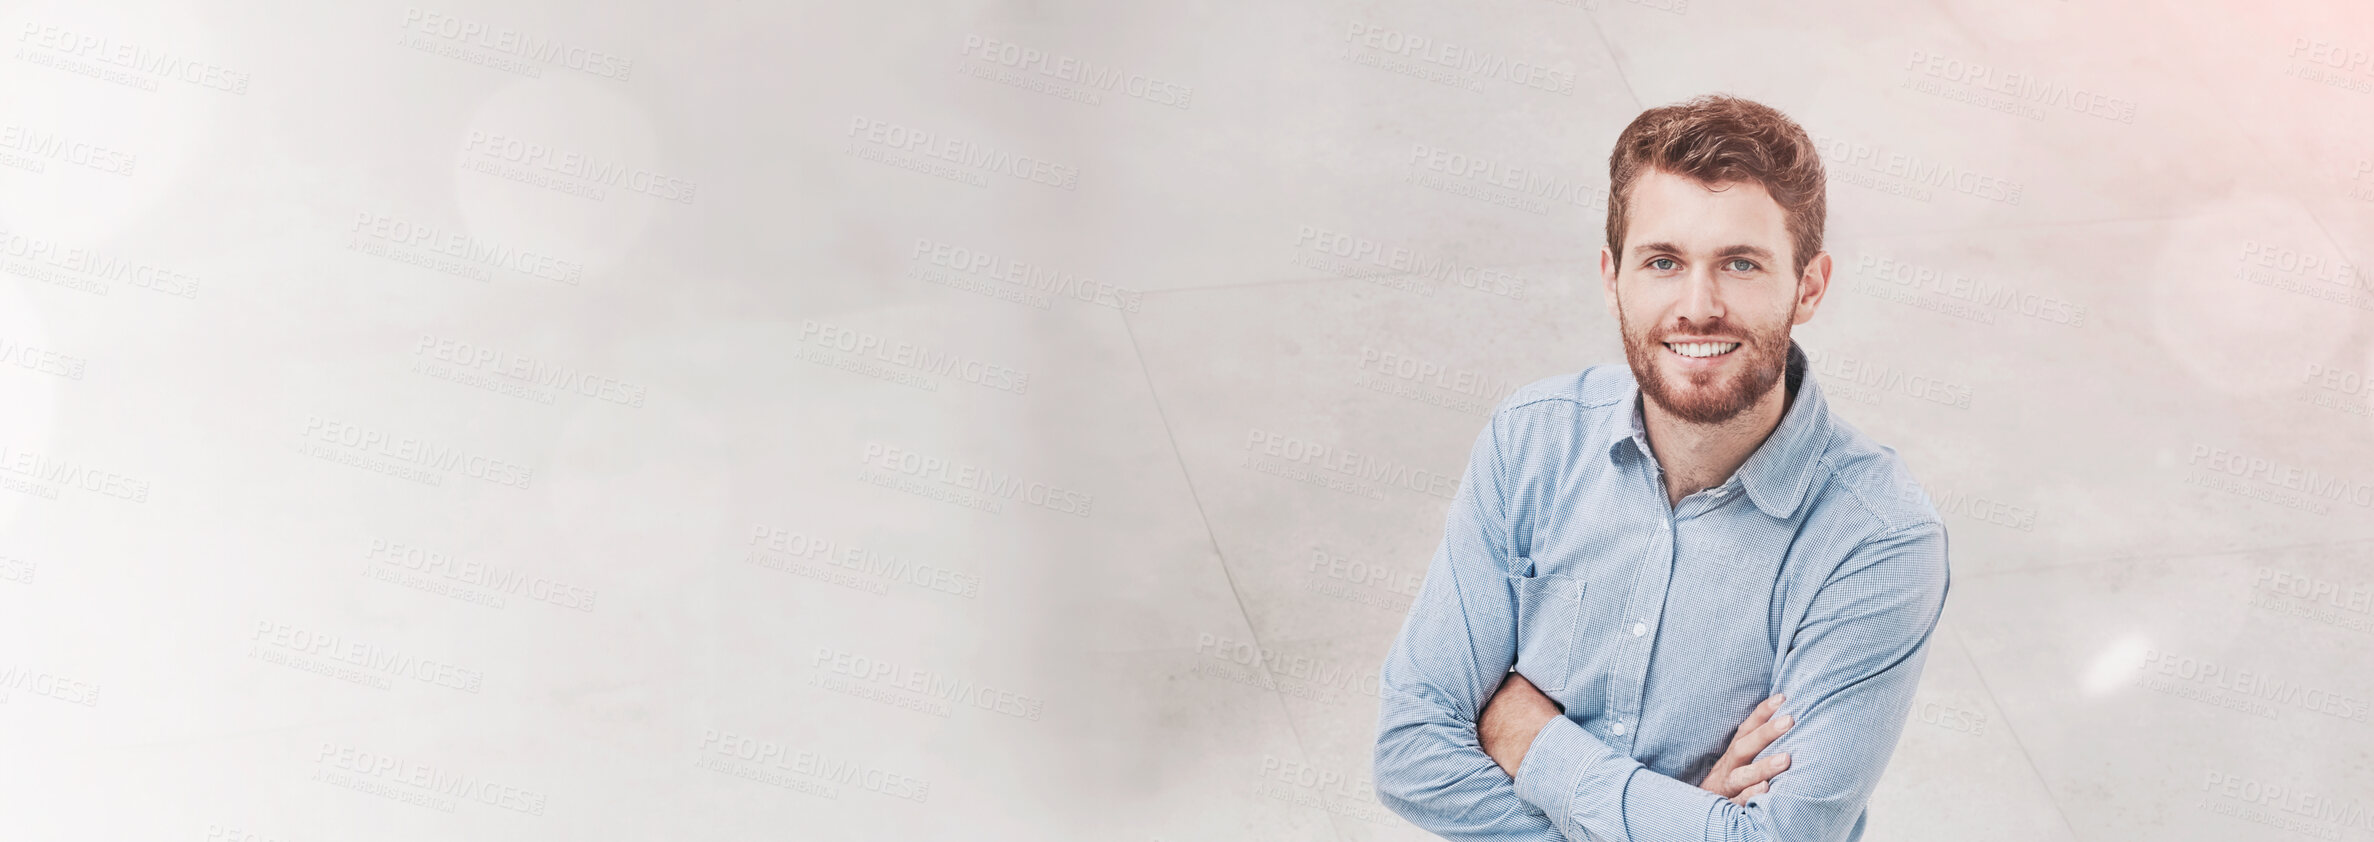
1375,342,1949,842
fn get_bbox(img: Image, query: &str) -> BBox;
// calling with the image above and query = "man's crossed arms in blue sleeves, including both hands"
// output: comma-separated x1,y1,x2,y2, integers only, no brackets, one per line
1375,420,1944,842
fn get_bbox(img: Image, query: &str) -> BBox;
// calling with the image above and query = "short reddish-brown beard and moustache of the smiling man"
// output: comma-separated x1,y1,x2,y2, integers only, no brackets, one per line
1617,301,1790,425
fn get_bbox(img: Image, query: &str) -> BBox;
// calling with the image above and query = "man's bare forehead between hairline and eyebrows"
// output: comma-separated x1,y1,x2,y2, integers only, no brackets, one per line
1624,168,1788,249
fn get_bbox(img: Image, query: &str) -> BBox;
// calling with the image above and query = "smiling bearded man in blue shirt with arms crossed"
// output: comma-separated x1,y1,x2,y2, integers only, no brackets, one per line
1375,95,1947,842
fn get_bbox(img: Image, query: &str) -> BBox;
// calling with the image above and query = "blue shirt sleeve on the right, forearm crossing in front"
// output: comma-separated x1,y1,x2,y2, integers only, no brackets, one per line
1515,522,1949,842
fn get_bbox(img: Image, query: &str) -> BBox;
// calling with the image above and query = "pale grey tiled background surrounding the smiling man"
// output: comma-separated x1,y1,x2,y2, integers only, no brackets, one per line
0,0,2374,842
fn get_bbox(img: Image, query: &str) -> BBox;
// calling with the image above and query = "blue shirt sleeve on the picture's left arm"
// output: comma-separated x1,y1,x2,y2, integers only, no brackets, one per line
1375,415,1564,840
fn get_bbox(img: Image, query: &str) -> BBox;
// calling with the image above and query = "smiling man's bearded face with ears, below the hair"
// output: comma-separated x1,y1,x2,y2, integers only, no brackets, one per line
1600,171,1830,425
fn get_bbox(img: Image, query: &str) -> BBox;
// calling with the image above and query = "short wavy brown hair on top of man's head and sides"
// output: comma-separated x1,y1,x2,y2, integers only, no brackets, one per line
1607,93,1830,278
